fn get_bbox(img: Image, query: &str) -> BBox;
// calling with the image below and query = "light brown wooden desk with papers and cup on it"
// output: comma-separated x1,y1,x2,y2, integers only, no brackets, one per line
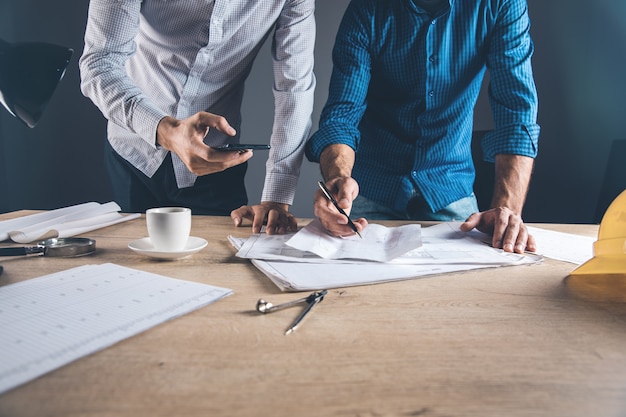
0,213,626,417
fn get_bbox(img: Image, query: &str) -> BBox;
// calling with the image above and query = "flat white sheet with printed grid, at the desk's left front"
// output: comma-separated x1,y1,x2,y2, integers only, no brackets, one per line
0,264,232,394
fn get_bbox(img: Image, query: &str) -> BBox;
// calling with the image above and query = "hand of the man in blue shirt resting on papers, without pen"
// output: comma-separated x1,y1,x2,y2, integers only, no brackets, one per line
461,207,537,253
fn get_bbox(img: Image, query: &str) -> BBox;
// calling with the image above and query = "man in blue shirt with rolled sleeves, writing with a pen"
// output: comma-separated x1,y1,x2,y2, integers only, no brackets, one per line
306,0,539,252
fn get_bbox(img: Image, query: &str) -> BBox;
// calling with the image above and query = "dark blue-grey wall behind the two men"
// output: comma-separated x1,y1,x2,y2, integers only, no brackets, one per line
0,0,626,223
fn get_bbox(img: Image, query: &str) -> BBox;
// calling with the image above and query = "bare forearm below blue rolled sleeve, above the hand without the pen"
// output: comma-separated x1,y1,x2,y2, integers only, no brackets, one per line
491,154,535,215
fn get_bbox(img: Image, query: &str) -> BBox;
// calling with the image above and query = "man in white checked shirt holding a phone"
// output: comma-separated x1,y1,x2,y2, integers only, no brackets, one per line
80,0,315,233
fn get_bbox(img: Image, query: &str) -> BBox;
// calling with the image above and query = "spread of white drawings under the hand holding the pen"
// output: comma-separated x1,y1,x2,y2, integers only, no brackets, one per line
229,220,543,291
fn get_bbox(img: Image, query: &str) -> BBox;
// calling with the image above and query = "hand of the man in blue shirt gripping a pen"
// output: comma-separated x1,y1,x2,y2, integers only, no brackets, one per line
313,177,367,236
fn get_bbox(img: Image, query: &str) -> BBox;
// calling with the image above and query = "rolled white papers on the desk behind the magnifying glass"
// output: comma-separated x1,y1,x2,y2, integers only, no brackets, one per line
0,202,140,243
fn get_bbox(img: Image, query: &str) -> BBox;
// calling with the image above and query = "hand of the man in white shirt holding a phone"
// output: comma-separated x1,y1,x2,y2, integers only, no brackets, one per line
156,112,252,176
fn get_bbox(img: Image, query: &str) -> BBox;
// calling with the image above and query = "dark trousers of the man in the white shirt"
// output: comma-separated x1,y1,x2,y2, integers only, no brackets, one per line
104,140,248,216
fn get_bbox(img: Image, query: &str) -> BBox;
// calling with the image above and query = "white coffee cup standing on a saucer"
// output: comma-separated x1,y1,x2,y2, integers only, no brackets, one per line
146,207,191,252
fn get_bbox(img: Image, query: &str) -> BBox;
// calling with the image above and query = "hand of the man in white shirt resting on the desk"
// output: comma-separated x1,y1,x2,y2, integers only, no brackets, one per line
230,201,298,235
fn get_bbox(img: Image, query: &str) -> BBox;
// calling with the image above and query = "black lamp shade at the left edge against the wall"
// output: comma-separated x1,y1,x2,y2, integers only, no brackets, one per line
0,39,73,128
